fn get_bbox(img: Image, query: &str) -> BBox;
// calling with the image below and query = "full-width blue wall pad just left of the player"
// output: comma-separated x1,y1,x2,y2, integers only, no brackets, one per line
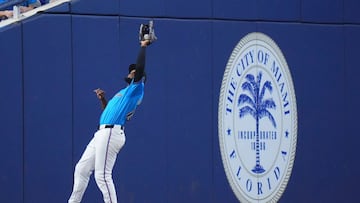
23,15,72,202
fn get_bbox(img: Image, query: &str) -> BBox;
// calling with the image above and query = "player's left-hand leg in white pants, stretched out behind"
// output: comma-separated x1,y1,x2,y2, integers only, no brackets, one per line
68,138,95,203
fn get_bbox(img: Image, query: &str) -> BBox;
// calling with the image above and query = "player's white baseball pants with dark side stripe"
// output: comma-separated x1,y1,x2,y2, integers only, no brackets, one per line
68,125,125,203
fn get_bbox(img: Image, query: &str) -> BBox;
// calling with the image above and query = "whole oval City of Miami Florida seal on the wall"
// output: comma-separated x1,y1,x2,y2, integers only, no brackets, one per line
218,32,297,202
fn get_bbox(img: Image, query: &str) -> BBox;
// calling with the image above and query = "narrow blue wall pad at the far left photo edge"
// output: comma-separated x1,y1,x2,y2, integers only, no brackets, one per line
0,22,24,202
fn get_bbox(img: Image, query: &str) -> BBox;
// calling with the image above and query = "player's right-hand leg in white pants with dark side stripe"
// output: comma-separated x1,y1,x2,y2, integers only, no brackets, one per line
94,128,125,203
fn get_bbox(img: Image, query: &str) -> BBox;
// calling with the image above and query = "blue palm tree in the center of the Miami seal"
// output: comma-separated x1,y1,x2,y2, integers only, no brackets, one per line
238,72,276,174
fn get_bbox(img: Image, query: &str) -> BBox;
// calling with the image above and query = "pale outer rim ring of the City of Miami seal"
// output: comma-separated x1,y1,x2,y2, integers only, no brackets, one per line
218,32,298,202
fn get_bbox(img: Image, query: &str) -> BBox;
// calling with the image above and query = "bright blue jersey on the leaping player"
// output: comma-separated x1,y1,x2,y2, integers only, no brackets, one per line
100,81,144,125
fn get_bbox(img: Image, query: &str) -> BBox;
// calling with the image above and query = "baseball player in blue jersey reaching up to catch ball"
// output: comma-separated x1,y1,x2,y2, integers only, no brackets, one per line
68,21,157,203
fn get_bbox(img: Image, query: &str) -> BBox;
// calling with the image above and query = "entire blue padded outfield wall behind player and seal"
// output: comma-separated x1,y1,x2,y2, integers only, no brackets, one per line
0,0,360,203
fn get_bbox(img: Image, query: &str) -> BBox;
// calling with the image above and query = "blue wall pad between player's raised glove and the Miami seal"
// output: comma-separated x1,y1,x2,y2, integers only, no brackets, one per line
159,20,212,203
